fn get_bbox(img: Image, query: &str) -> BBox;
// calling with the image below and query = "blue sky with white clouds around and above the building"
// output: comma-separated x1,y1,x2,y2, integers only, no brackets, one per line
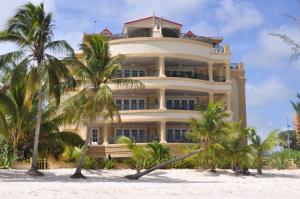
0,0,300,135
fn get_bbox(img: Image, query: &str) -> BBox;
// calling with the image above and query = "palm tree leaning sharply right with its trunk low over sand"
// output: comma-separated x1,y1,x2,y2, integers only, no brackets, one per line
125,102,229,180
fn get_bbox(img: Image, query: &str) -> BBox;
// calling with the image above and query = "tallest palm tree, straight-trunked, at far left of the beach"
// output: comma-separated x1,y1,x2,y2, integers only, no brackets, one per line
0,3,74,176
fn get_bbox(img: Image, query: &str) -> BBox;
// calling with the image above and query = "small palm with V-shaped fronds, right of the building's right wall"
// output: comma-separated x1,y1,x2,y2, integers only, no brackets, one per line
249,129,278,174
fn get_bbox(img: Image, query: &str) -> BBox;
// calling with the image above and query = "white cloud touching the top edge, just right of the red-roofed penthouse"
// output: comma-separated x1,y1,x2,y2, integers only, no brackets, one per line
192,0,263,36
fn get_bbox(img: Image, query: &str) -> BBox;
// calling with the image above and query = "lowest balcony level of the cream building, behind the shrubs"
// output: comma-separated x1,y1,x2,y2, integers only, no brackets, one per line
88,121,192,145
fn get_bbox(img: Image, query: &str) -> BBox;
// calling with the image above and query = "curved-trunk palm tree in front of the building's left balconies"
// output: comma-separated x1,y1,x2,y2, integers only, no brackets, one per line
64,35,143,178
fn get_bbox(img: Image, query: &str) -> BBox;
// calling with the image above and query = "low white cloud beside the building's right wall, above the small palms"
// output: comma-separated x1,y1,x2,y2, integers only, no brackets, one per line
246,77,293,107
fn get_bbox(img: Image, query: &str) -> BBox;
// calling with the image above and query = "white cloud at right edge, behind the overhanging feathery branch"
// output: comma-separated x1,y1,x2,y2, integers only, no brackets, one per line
243,25,300,69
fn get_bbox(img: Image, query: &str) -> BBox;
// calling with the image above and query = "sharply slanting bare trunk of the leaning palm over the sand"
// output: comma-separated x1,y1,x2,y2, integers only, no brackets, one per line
125,148,203,180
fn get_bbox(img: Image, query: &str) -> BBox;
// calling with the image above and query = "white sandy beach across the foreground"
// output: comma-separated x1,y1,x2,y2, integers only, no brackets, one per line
0,169,300,199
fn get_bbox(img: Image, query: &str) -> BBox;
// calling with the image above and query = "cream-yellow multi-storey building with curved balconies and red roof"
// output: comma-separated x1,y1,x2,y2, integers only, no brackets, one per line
71,16,246,157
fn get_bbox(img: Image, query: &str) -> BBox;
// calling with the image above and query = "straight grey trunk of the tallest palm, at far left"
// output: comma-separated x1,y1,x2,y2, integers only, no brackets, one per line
27,89,44,176
